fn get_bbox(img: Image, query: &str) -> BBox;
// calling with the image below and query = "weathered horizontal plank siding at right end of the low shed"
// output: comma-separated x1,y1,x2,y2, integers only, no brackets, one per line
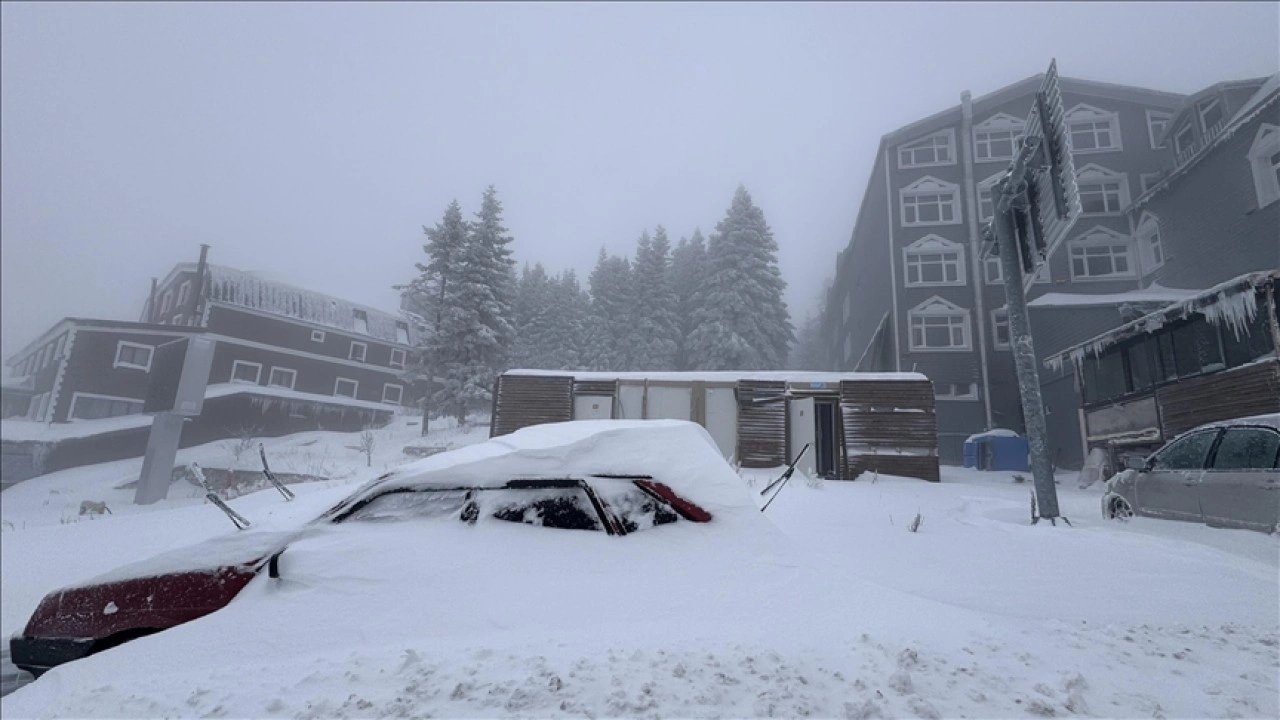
840,380,941,483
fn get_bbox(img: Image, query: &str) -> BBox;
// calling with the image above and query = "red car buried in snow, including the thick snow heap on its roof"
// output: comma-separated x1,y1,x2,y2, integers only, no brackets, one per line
10,420,759,675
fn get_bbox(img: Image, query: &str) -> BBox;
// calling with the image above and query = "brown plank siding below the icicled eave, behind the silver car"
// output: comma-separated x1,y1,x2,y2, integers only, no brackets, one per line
1156,359,1280,439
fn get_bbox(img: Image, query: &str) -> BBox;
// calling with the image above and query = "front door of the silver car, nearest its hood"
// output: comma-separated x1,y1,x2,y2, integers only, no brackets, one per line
1137,429,1219,521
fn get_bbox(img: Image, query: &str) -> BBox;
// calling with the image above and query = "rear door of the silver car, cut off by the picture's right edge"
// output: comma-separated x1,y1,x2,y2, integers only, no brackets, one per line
1199,427,1280,530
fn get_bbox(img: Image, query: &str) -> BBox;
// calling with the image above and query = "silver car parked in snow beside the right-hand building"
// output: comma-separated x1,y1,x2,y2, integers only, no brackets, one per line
1102,414,1280,532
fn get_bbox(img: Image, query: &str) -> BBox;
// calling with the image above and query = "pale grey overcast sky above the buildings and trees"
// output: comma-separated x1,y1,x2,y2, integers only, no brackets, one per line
0,3,1280,359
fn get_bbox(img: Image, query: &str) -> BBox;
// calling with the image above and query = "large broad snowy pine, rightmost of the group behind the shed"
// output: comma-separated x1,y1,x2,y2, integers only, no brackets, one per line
690,186,794,370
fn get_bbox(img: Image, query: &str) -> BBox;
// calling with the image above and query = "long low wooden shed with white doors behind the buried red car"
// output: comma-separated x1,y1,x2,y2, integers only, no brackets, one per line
489,370,938,482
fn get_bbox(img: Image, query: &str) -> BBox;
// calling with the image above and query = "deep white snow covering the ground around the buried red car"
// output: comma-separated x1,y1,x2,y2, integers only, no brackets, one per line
0,424,1280,717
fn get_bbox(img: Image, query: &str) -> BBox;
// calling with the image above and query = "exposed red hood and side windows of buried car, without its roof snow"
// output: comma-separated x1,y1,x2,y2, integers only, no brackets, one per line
10,471,712,676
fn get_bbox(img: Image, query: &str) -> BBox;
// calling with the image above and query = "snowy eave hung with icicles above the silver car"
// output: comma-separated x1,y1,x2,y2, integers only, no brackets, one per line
1044,269,1280,370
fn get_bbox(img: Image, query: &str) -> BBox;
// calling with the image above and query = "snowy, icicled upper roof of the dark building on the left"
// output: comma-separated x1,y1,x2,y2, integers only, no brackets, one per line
192,263,413,343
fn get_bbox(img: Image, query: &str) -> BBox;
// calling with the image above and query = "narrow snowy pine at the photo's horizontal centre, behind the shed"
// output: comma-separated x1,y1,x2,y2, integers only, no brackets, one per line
632,225,680,370
